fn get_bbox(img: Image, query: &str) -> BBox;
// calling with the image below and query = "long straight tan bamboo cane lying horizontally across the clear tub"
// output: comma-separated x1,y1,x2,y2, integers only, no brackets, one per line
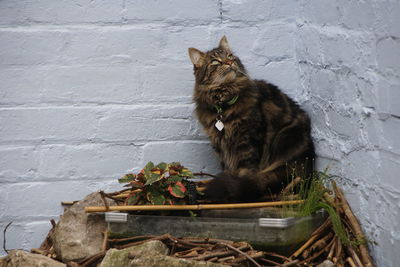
85,200,304,212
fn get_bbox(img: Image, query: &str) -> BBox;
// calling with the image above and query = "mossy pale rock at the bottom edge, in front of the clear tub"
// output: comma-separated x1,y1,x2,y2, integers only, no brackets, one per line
100,240,169,267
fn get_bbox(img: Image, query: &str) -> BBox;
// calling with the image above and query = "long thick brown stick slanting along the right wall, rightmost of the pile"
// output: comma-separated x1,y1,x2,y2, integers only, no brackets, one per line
332,181,374,267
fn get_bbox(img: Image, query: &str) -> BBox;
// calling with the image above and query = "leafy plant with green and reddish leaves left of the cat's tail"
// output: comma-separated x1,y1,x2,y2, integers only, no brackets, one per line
118,162,196,205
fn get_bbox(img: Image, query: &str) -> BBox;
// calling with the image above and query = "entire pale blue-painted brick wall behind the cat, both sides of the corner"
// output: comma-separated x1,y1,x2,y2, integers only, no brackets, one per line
0,0,400,266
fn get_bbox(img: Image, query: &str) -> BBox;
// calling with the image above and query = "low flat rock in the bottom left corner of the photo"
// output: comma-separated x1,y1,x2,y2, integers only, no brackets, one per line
0,250,67,267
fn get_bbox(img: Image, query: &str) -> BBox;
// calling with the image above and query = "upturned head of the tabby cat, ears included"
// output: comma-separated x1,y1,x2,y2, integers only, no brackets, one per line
189,36,247,86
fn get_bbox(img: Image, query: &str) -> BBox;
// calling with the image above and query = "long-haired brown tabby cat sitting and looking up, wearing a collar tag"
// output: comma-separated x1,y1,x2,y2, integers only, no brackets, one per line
189,36,315,202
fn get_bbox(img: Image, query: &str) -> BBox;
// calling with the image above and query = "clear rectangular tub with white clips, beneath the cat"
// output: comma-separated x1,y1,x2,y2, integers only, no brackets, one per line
106,208,326,254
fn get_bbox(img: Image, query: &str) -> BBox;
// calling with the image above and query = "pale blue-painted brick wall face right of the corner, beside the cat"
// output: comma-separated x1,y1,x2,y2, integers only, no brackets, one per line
296,0,400,267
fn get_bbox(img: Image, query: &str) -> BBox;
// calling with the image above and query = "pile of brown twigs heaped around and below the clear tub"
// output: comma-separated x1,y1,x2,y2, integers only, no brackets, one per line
32,182,374,267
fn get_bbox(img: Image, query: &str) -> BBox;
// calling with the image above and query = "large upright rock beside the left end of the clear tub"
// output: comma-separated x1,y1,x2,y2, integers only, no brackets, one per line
52,192,115,262
